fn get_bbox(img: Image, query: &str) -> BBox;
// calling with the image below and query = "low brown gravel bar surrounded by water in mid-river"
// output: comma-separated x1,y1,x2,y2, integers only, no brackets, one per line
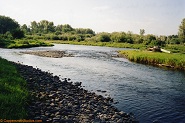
21,50,73,58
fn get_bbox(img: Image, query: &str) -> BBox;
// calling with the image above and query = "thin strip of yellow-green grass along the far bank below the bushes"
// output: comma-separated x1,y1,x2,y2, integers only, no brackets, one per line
46,41,146,49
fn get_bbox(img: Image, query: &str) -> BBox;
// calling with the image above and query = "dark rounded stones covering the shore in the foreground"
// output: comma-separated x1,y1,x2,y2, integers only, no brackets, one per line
15,64,137,123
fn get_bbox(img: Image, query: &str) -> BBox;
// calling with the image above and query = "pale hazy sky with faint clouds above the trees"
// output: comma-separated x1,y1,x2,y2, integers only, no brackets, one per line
0,0,185,35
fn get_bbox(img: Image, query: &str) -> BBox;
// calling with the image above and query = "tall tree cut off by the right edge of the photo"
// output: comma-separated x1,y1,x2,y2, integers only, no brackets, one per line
178,18,185,43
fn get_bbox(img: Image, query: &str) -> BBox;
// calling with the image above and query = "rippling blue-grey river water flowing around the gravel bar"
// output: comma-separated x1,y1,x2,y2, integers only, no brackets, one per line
0,44,185,123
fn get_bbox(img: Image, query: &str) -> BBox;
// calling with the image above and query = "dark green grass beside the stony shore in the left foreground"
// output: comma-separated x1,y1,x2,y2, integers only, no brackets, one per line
0,58,28,119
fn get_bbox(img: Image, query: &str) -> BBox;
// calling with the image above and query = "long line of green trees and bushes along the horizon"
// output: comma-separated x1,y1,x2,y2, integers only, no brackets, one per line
0,16,185,46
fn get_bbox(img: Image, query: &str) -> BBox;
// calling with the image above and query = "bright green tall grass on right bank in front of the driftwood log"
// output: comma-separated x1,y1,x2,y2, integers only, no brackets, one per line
119,51,185,70
